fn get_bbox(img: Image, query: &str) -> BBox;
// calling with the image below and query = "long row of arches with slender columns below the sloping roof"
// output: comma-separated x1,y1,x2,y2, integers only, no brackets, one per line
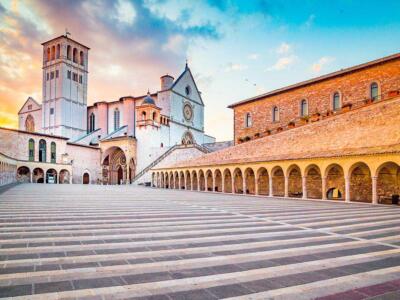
152,162,400,203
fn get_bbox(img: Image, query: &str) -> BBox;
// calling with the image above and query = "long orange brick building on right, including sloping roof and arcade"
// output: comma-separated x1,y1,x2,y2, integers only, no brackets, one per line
153,54,400,204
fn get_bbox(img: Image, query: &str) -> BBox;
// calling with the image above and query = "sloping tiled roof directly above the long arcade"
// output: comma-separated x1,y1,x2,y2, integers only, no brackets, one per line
162,98,400,167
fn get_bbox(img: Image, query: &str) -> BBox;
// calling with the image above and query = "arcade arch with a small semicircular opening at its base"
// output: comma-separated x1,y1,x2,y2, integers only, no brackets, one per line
323,164,345,200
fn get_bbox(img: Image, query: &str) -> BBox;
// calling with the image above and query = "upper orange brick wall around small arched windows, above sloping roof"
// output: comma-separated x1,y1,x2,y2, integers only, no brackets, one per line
234,58,400,143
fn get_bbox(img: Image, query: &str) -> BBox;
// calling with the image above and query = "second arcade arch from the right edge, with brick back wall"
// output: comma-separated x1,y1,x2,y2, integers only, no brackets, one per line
349,162,372,202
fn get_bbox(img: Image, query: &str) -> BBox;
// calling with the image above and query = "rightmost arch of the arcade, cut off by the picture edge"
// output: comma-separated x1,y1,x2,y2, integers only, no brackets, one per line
375,162,400,202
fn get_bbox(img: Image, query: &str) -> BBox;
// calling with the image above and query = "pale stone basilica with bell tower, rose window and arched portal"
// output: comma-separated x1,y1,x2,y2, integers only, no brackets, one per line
0,35,220,184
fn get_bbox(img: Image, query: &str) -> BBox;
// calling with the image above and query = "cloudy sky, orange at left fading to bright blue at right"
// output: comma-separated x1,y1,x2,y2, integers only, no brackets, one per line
0,0,400,141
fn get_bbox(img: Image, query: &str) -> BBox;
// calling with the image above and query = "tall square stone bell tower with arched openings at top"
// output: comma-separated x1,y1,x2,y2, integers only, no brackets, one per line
42,32,89,139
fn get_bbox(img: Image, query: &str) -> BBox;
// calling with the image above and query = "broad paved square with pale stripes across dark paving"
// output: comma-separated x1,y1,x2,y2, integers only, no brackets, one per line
0,184,400,300
